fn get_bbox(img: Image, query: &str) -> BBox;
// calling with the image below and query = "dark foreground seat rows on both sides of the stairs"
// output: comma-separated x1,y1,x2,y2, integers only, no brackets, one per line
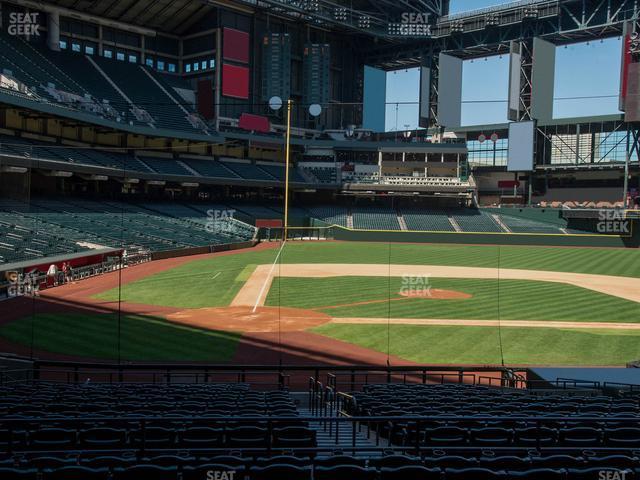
0,382,640,480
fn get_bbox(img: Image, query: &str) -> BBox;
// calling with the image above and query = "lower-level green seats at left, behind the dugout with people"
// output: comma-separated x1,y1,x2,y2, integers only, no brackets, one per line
0,198,254,263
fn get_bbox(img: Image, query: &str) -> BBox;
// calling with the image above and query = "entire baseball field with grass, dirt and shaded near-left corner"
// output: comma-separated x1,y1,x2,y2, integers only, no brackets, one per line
0,242,640,365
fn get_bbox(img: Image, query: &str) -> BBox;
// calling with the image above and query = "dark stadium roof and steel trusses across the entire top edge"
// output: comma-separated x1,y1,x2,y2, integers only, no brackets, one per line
28,0,640,55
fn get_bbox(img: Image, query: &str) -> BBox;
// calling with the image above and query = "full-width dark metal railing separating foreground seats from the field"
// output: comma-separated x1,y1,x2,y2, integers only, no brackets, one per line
0,356,640,396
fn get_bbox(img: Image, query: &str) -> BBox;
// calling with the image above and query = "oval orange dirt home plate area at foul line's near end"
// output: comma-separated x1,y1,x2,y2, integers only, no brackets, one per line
167,307,331,333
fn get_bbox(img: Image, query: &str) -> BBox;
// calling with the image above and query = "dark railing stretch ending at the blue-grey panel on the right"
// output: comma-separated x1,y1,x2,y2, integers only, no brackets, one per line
15,364,526,391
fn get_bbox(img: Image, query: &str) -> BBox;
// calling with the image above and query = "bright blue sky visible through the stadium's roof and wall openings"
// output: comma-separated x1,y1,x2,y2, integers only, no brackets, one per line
386,0,621,131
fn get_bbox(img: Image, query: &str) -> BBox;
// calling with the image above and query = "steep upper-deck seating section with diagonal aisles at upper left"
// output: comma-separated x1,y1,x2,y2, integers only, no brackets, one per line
0,35,206,133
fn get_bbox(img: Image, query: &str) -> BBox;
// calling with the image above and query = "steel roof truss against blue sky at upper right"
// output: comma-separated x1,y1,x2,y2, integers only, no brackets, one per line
367,0,640,70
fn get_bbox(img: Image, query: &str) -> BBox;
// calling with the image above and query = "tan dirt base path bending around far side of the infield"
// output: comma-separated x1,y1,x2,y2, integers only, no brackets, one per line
231,263,640,307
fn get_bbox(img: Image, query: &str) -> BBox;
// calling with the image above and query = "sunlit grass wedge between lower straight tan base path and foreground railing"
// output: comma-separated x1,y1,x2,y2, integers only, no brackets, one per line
313,324,640,366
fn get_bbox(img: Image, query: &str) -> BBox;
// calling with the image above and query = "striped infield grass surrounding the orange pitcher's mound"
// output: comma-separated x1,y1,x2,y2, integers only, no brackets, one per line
266,277,640,322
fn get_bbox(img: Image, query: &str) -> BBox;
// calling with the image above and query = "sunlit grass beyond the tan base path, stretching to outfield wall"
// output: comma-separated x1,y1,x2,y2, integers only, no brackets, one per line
97,242,640,308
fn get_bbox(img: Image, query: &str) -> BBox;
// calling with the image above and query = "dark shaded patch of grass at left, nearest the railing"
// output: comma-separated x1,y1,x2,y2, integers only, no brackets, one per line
0,314,240,362
